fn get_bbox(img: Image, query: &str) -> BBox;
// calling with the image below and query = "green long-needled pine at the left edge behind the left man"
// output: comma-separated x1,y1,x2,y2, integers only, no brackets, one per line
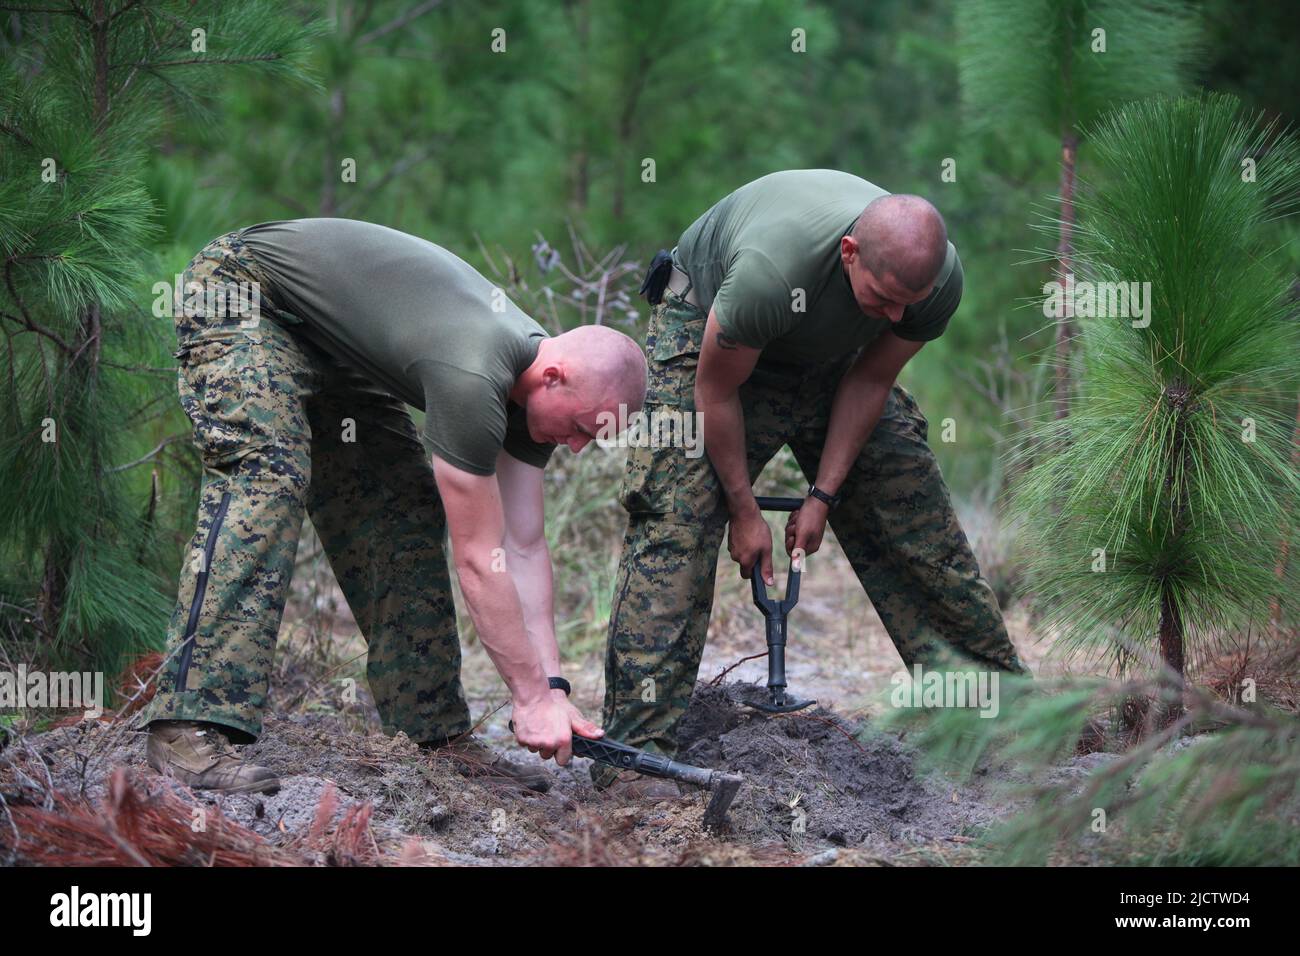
0,3,319,674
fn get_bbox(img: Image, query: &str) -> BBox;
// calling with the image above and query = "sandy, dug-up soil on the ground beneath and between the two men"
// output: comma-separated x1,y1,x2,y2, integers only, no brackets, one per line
0,522,1104,865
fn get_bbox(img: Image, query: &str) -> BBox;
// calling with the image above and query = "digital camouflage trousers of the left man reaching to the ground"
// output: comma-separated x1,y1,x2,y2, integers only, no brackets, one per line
142,233,471,743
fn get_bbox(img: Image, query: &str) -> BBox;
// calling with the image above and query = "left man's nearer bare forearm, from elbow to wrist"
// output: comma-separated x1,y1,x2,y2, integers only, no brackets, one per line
456,564,550,701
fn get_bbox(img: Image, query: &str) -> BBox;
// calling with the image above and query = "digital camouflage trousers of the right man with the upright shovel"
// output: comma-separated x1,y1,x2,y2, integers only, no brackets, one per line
593,291,1028,786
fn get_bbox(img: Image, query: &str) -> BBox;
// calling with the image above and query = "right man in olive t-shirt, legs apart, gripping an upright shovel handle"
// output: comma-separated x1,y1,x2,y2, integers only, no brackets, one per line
593,169,1024,795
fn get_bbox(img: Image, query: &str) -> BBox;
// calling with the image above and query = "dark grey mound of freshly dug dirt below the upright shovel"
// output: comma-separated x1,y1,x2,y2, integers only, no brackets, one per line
679,683,993,849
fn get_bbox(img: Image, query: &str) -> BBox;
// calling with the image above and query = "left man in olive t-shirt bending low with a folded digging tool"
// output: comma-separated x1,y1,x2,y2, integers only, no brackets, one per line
143,219,645,792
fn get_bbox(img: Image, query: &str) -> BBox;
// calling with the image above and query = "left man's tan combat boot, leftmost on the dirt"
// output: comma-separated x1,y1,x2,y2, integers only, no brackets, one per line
147,721,280,793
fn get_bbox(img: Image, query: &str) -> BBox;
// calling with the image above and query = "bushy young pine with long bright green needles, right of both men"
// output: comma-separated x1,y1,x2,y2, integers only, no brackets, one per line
1011,95,1300,671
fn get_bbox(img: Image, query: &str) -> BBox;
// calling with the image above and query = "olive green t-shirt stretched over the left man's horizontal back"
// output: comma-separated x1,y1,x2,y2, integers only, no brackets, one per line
239,219,555,475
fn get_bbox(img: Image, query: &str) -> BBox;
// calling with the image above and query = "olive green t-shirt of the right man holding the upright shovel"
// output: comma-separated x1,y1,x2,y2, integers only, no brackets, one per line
676,169,962,365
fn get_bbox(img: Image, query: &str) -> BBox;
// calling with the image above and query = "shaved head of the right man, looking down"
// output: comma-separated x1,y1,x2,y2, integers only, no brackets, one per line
850,193,948,291
